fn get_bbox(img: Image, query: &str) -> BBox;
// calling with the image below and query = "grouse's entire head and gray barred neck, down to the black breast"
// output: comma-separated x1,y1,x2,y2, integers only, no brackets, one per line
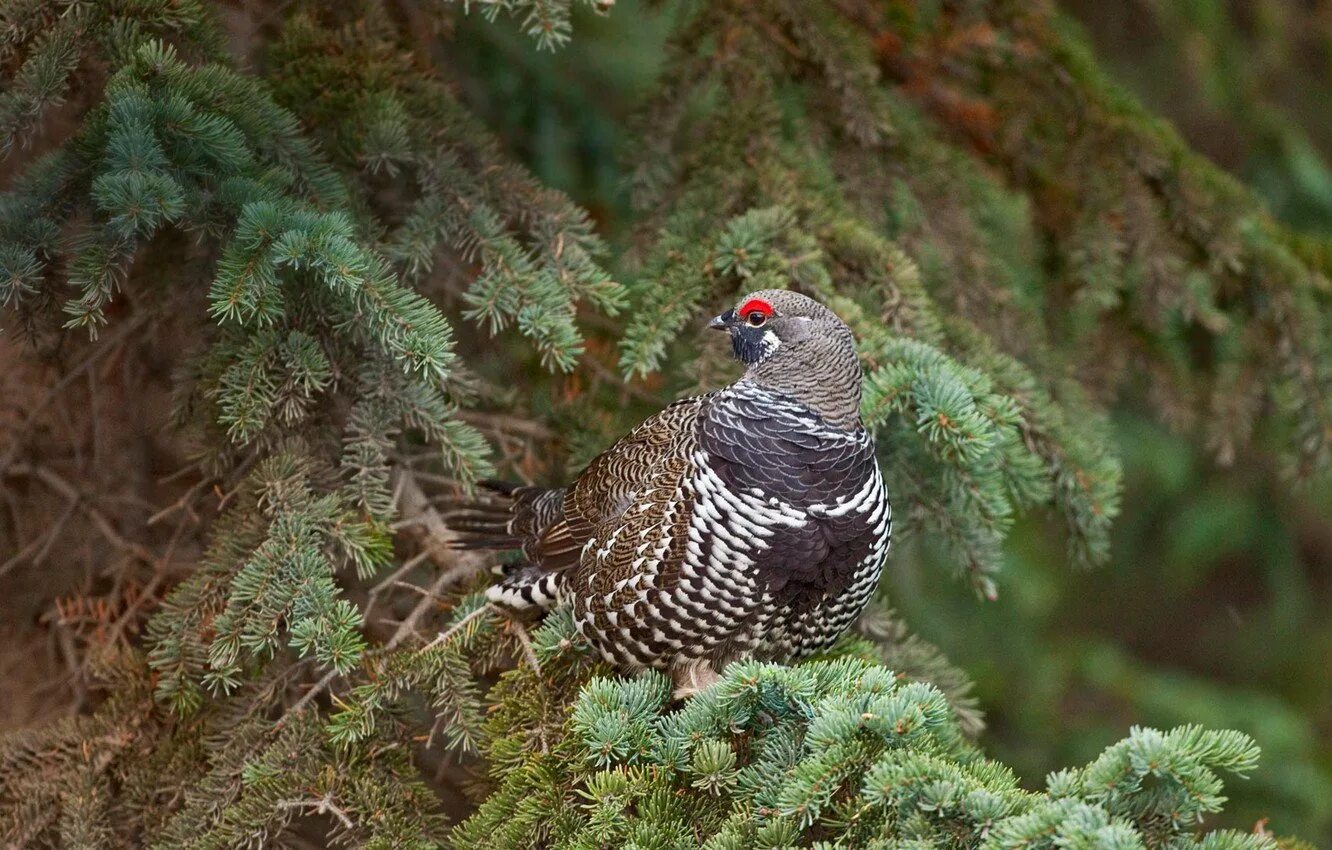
707,289,860,426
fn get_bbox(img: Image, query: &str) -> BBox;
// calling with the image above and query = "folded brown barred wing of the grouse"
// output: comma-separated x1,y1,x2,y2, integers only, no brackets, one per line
541,396,709,569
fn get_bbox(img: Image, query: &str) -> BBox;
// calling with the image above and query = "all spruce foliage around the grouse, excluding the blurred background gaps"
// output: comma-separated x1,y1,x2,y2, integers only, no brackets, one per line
0,0,1332,850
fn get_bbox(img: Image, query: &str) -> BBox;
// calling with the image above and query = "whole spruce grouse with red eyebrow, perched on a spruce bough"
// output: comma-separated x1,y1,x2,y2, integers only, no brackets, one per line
446,289,892,697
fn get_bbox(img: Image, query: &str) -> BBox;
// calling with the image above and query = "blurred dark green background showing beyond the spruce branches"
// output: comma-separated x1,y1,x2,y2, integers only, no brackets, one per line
440,0,1332,847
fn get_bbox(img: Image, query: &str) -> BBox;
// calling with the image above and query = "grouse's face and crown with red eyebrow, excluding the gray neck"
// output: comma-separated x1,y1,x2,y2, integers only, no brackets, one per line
707,289,854,366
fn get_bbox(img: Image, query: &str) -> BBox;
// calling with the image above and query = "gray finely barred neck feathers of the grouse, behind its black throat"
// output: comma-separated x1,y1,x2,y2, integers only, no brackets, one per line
742,321,860,430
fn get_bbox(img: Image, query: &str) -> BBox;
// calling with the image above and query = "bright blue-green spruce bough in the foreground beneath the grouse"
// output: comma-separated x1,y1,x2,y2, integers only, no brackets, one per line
453,620,1275,850
